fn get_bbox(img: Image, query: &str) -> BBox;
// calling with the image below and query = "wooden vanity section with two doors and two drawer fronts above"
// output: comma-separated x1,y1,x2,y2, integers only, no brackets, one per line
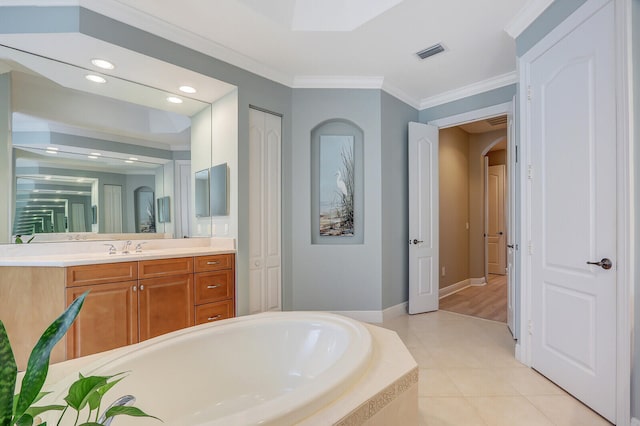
66,257,194,359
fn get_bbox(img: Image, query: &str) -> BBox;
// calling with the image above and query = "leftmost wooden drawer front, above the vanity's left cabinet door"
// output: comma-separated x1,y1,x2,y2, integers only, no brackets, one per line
67,262,138,287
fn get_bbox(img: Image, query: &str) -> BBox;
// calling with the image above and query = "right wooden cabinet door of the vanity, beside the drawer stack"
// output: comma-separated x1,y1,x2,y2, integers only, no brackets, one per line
138,274,194,341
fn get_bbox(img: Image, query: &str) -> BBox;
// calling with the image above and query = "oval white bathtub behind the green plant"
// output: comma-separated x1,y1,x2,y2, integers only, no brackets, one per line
45,312,372,426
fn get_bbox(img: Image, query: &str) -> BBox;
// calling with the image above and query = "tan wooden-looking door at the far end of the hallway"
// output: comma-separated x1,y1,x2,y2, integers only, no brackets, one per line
486,164,507,275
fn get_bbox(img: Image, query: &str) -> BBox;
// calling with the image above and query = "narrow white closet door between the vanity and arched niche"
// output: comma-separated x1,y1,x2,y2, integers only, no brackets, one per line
249,109,282,314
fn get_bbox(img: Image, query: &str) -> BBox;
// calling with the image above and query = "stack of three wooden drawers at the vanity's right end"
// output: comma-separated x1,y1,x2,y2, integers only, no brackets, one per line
194,254,236,325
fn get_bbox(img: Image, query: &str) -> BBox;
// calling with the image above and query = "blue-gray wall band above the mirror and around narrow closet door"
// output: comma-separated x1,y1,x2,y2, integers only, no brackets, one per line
0,6,292,315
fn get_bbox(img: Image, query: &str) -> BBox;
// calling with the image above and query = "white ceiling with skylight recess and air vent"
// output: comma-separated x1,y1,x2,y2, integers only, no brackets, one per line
80,0,532,106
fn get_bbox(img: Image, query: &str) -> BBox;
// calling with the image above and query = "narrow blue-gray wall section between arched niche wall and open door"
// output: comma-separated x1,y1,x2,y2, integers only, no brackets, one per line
381,92,418,309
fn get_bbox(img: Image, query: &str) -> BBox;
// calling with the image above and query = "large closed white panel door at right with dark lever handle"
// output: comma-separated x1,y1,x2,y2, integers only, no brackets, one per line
528,1,616,423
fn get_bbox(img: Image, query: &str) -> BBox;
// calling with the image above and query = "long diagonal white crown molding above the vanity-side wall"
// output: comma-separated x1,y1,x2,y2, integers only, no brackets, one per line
78,0,293,87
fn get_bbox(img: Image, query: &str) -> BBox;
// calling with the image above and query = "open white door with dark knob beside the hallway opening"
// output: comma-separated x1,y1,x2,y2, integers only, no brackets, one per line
409,123,440,314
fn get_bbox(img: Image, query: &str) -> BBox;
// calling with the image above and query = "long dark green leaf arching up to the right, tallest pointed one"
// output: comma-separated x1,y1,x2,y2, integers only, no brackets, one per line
16,292,88,418
